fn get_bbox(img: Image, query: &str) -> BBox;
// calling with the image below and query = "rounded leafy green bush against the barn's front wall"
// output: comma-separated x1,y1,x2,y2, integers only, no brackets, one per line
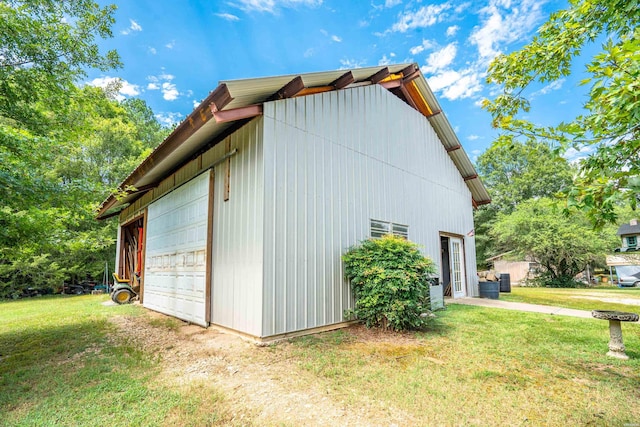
342,235,436,331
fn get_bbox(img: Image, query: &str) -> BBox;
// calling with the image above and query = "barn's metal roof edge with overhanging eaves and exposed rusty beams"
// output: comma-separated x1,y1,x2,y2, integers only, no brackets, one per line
97,63,491,219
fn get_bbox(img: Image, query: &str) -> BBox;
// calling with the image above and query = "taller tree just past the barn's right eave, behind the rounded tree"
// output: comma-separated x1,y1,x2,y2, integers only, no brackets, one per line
474,140,573,268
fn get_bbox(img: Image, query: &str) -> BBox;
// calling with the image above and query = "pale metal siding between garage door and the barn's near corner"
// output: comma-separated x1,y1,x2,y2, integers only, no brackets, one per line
211,118,264,336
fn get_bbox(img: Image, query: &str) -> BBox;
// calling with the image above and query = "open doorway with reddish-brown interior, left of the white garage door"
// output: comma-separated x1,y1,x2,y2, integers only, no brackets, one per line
117,216,145,296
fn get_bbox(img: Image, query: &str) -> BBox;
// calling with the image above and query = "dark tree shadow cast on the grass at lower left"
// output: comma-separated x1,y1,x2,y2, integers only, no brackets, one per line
0,319,159,425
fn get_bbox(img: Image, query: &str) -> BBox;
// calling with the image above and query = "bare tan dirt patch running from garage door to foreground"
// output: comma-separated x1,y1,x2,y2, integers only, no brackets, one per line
107,312,416,426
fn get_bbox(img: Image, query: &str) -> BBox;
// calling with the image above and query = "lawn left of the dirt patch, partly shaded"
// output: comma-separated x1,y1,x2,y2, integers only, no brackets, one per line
0,295,235,426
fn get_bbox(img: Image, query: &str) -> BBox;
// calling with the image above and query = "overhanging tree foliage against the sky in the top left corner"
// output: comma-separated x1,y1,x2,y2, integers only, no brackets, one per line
0,0,120,133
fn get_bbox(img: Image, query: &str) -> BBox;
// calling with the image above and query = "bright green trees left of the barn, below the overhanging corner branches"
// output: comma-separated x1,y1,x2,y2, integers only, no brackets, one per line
0,87,168,297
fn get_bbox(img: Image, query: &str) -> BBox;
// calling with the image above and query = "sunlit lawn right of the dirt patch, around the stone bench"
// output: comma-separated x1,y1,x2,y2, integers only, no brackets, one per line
286,305,640,426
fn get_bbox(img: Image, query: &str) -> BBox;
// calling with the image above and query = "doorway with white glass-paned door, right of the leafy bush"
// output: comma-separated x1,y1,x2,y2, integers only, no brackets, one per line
440,235,467,298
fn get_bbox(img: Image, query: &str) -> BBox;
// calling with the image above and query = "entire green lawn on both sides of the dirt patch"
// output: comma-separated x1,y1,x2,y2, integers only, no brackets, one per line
0,291,640,426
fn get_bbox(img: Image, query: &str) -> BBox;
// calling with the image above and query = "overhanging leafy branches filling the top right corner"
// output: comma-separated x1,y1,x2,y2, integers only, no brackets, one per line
484,0,640,227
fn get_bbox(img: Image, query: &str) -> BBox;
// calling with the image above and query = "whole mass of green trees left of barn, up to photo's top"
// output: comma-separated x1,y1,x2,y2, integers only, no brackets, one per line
0,0,167,297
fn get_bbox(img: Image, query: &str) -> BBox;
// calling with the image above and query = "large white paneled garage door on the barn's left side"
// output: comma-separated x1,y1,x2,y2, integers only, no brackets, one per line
144,172,209,326
